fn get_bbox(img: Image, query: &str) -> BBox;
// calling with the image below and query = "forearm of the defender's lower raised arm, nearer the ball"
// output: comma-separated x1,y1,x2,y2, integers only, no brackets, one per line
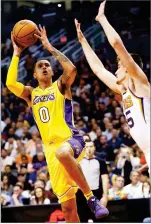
81,39,104,74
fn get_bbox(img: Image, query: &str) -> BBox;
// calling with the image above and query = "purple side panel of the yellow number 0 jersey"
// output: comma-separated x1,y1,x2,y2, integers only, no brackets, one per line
64,99,79,135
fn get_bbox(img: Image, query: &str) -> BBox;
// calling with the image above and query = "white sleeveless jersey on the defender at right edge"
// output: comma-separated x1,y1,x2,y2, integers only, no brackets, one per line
122,88,150,152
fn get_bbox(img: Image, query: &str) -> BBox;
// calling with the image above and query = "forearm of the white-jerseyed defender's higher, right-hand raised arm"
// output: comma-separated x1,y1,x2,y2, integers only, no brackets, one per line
99,16,122,48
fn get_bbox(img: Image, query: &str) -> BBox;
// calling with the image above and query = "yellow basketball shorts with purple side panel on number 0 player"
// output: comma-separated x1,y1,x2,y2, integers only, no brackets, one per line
44,136,85,203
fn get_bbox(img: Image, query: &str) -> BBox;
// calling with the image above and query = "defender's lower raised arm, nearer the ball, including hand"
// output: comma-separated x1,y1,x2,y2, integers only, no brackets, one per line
75,19,120,94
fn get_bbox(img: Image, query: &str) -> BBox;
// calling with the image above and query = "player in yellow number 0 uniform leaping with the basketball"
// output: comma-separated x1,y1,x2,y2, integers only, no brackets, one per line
6,26,109,222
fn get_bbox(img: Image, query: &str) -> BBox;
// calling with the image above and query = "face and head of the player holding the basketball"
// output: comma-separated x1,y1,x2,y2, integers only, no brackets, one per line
34,60,53,81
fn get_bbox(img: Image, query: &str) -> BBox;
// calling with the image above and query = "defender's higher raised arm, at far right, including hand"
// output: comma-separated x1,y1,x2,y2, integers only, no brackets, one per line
96,0,148,84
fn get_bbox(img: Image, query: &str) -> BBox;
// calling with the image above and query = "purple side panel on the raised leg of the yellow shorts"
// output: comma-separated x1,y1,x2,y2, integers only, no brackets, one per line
67,136,85,159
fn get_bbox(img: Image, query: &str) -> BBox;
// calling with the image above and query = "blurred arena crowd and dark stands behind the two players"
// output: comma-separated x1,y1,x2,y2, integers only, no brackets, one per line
1,0,150,222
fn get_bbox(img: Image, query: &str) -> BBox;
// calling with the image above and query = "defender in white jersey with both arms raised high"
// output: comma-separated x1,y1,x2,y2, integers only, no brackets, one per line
75,1,150,170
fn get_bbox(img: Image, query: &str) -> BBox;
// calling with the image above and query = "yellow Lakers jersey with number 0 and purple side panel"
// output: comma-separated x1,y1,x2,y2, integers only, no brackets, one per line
31,81,79,145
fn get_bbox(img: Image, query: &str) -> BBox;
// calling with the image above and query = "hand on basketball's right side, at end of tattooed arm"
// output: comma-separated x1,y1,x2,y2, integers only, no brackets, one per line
34,25,51,48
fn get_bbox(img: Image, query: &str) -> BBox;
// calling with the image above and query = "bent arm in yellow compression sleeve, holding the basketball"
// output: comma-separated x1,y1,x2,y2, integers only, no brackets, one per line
6,33,31,104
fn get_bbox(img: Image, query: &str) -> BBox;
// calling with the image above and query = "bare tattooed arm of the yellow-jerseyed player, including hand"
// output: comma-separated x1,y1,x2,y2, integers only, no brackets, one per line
35,26,77,87
